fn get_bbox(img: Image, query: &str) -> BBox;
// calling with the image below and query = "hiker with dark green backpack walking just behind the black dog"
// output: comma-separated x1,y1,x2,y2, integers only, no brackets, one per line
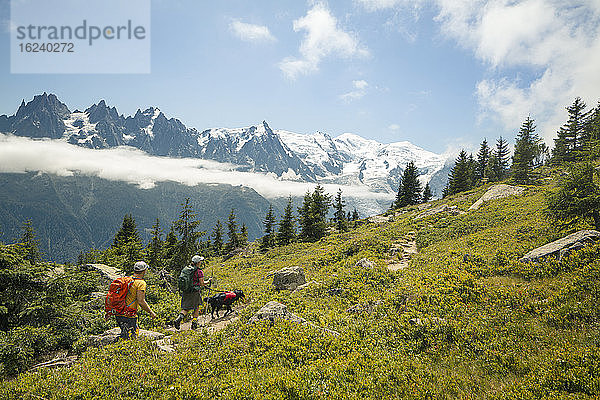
173,255,212,329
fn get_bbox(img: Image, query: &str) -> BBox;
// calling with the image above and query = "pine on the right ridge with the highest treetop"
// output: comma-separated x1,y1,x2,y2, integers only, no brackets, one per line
552,97,589,163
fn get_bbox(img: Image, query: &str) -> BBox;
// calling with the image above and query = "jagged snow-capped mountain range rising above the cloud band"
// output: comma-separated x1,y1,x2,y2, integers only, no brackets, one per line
0,93,446,195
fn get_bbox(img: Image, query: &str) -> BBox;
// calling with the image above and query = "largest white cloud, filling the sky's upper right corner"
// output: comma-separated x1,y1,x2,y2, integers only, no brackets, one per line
436,0,600,142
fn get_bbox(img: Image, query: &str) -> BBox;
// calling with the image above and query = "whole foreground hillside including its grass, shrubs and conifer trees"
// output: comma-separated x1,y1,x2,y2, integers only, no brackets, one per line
0,94,600,399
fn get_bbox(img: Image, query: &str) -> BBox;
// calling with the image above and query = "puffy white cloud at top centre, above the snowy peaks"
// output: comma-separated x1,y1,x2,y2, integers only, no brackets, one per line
279,3,369,79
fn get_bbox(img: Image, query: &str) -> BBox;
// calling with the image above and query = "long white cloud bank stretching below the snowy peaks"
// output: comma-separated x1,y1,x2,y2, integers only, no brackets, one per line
0,134,393,200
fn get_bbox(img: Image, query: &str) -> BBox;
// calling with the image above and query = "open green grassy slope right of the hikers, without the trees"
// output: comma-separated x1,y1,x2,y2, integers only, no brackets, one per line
0,179,600,399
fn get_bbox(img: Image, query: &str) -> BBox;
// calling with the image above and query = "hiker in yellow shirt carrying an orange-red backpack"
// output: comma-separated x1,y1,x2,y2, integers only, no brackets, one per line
105,261,157,339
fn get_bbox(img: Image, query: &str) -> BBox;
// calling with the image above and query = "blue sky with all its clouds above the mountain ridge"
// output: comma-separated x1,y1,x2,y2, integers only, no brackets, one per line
0,0,600,153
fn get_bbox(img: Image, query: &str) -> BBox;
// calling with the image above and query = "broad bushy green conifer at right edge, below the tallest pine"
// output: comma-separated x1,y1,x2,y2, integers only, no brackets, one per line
547,162,600,230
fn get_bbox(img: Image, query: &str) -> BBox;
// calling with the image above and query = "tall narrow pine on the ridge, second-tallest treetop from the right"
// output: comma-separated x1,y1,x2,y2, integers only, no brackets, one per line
512,117,540,184
